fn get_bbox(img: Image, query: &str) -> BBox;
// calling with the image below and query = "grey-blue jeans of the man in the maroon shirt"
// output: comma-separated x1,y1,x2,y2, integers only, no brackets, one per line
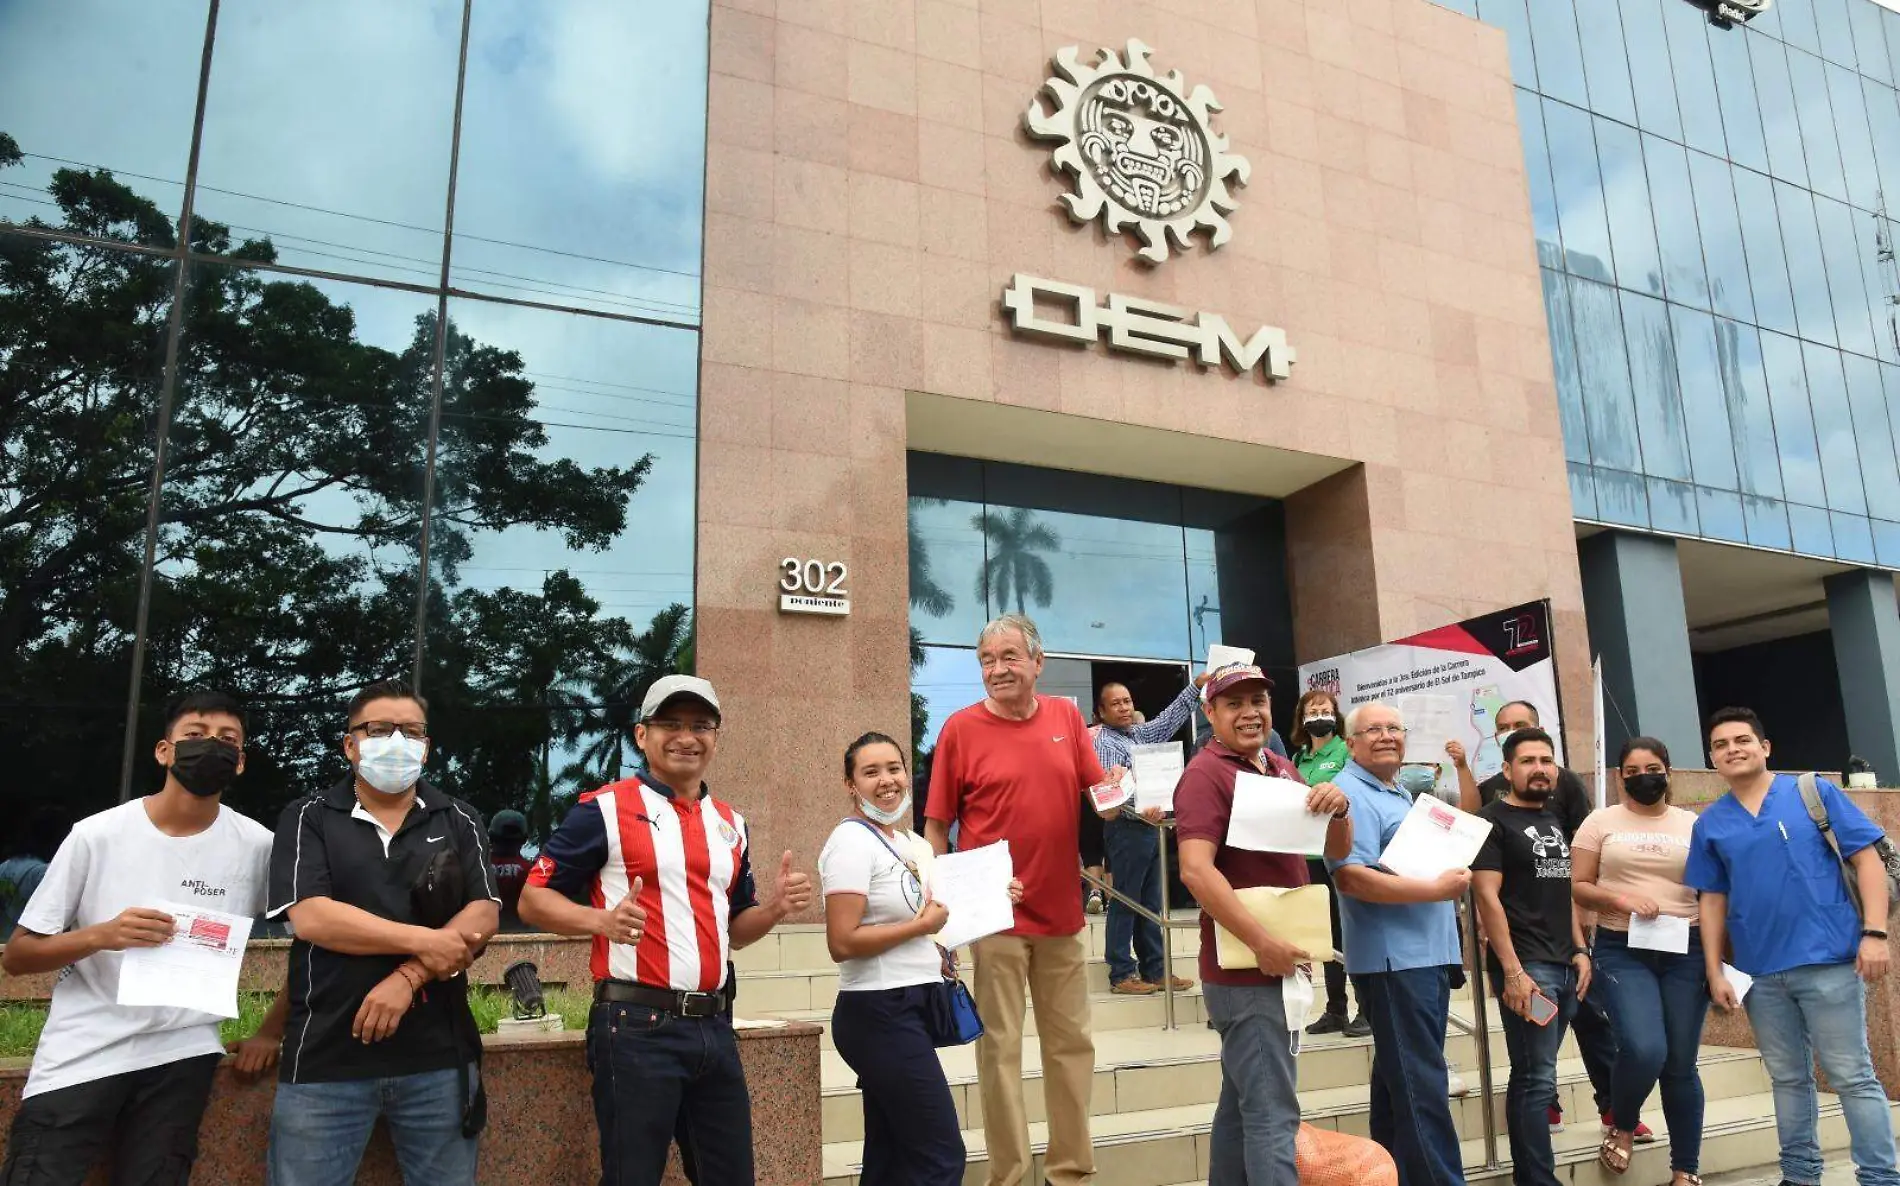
1203,981,1300,1186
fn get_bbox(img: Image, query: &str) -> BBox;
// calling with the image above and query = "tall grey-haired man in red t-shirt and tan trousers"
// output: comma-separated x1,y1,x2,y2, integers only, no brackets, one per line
923,614,1123,1186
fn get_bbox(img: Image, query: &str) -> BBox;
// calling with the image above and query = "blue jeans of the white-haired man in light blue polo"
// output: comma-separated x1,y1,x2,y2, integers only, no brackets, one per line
1353,967,1465,1186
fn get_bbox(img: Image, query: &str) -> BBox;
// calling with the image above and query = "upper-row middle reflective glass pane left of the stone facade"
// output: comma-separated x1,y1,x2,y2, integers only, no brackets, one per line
196,0,466,287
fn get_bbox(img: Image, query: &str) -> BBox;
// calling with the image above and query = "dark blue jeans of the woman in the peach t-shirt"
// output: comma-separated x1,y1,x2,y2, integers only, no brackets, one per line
1590,928,1708,1173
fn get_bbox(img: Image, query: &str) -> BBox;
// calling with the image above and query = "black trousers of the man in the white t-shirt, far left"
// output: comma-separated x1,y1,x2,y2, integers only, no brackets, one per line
0,1055,222,1186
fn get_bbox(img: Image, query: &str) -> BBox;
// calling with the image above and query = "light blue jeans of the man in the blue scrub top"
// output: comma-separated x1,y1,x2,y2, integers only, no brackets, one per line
1742,964,1900,1186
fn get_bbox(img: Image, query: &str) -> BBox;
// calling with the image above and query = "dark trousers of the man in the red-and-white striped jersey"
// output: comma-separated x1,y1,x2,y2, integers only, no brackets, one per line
587,1002,752,1186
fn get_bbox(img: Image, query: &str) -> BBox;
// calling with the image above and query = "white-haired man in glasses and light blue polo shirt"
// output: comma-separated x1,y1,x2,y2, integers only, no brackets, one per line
1326,701,1471,1186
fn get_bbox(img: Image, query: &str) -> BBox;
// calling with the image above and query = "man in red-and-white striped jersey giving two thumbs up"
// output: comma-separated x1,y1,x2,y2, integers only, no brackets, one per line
521,675,811,1186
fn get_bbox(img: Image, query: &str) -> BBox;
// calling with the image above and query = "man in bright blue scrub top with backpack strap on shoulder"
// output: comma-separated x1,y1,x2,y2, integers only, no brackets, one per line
1683,709,1900,1186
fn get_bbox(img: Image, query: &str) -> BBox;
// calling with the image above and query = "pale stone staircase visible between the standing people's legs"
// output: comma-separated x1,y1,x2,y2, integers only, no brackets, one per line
737,918,1877,1186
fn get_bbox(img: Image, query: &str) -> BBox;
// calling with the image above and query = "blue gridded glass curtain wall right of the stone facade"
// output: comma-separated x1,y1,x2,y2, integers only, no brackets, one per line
1440,0,1900,568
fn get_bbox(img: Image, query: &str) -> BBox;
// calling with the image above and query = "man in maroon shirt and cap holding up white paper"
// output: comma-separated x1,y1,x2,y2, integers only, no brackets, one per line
1174,665,1353,1186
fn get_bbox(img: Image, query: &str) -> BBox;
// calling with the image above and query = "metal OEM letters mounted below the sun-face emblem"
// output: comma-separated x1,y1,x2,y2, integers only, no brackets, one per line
1003,272,1294,378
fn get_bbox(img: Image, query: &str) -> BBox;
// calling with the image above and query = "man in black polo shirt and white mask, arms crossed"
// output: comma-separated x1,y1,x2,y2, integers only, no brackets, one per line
270,680,500,1186
